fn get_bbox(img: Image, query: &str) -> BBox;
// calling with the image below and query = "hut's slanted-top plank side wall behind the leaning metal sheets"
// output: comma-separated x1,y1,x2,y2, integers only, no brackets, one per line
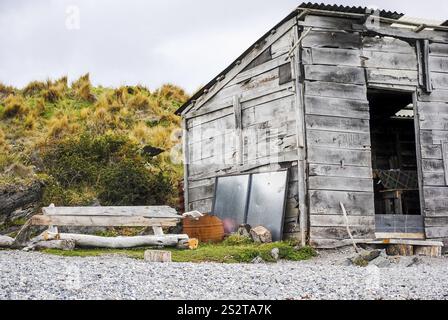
186,19,299,237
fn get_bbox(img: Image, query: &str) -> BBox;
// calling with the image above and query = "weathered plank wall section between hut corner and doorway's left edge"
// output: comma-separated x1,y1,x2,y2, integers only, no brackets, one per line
301,16,375,247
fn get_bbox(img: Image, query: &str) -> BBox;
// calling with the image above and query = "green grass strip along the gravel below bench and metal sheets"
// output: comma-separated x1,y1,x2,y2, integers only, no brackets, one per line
43,242,316,263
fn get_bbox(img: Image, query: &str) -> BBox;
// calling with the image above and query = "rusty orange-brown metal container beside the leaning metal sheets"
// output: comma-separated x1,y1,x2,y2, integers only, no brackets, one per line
183,215,224,243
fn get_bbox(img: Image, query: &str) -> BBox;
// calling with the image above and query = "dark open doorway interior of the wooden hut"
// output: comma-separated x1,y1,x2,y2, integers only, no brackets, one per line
368,90,420,215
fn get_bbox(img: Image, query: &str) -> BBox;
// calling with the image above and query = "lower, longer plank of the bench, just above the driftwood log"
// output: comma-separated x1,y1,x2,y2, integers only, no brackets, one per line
31,215,179,227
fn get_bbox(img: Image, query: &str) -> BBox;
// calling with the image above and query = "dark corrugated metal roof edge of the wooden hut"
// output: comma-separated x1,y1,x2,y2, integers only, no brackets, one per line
175,2,412,115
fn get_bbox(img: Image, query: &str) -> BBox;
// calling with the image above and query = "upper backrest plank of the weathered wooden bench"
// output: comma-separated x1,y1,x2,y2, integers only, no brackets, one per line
42,206,180,218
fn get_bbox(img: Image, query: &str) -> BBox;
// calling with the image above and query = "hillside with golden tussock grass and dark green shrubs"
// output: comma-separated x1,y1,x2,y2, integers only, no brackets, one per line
0,74,188,210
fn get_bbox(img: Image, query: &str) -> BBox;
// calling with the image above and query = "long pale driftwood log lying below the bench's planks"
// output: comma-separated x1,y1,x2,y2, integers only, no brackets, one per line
46,232,188,249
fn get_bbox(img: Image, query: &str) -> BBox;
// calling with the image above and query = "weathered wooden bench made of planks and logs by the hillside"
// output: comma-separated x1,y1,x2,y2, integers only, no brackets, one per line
16,205,188,248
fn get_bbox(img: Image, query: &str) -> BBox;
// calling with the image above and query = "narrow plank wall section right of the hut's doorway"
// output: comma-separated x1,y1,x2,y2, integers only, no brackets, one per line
417,43,448,245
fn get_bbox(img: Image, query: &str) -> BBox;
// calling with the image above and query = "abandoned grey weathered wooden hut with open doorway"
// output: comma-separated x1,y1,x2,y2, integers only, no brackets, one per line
177,3,448,248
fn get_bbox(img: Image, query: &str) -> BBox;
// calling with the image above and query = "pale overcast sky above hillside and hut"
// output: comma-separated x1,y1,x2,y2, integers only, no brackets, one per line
0,0,448,93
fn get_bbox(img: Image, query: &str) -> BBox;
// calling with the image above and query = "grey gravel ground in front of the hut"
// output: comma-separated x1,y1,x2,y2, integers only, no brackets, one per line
0,251,448,300
